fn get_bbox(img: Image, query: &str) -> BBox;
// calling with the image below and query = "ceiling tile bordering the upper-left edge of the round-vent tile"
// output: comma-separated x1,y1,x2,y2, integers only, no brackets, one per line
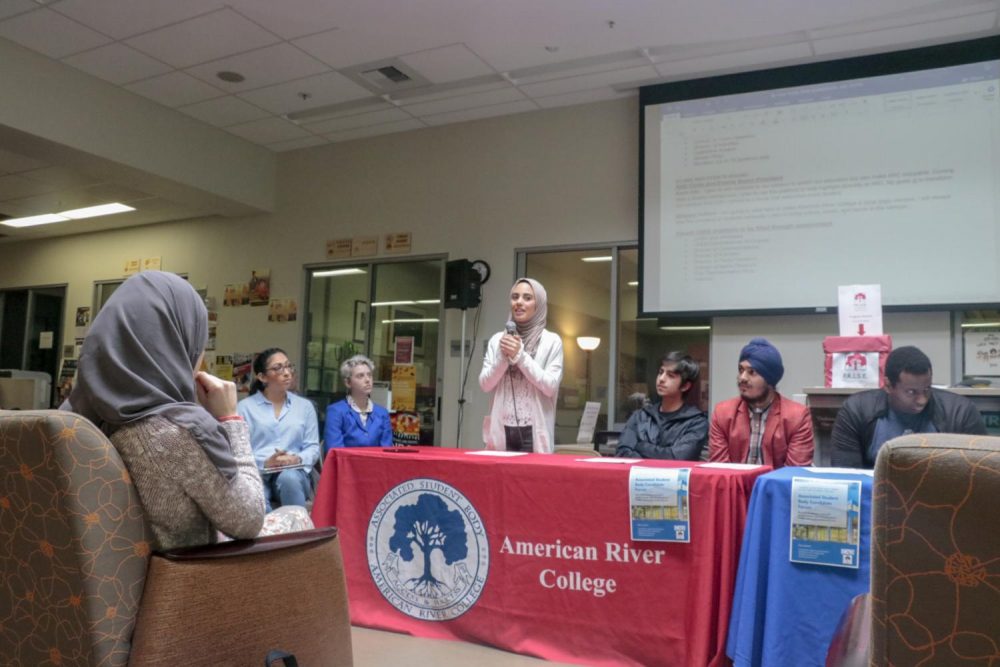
127,9,278,67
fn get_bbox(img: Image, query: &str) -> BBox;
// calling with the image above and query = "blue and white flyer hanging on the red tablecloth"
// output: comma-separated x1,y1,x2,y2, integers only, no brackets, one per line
628,466,691,542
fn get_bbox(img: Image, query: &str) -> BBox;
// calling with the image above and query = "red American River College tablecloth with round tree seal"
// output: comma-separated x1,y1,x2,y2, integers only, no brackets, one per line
313,448,770,667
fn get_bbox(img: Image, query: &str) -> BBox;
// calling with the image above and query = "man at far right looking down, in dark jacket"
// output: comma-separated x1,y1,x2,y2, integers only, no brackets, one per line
830,345,986,468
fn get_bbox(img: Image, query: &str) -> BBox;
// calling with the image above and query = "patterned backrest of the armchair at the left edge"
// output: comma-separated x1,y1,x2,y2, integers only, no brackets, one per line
0,410,150,667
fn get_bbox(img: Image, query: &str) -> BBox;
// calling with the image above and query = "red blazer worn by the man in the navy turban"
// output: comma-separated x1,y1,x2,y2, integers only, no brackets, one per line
708,394,814,468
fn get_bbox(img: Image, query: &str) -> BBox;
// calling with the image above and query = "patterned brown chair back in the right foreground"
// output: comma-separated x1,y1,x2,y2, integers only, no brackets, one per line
871,434,1000,667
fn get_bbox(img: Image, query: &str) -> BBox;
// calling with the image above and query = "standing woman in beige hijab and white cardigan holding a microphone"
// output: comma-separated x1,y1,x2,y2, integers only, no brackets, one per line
479,278,563,454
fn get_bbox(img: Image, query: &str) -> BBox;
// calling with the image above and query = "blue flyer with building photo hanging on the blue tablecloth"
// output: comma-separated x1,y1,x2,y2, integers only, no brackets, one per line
789,477,861,569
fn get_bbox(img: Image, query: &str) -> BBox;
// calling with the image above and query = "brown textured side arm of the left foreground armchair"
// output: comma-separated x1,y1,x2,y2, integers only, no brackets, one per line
129,528,353,667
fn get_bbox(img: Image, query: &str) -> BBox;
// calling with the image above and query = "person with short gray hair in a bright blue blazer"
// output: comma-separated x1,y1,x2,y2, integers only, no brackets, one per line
323,354,392,451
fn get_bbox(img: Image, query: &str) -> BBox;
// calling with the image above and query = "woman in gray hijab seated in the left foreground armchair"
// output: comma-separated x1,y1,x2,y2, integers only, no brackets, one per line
62,271,312,550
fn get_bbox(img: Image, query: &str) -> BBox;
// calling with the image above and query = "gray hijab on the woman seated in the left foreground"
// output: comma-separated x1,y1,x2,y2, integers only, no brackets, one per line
62,271,236,479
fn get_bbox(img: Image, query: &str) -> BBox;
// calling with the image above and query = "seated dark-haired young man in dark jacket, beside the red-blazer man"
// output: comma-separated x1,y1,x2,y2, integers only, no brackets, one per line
615,352,708,461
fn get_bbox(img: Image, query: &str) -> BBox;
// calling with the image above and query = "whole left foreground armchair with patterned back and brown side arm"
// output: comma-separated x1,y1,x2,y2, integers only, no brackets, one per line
0,410,352,667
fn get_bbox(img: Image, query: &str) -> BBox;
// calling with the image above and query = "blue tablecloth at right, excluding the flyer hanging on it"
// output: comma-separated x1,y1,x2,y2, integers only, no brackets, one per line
726,468,872,667
